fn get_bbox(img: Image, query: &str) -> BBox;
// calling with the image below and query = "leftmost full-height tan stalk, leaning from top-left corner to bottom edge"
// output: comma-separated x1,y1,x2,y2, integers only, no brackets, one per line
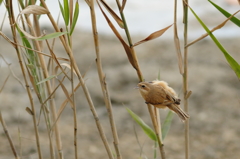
6,0,42,159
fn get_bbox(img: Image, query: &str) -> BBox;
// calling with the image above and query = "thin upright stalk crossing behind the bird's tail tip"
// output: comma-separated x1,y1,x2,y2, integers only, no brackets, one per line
183,0,189,159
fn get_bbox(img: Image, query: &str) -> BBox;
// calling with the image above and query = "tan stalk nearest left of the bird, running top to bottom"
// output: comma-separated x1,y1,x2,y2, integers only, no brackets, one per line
89,0,122,159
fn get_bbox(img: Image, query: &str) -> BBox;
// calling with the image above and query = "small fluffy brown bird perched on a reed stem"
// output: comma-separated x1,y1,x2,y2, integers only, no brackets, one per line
138,80,189,121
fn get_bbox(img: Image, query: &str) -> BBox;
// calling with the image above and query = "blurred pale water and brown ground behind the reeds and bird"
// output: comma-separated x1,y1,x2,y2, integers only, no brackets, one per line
0,0,240,159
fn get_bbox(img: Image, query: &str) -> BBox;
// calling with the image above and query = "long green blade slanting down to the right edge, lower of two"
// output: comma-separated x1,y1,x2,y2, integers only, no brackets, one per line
189,7,240,79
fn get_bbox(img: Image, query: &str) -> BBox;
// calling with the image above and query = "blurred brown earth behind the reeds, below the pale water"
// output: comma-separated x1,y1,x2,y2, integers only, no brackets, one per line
0,32,240,159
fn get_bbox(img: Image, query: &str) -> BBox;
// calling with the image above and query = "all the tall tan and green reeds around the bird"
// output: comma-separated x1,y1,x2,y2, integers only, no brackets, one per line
0,0,240,159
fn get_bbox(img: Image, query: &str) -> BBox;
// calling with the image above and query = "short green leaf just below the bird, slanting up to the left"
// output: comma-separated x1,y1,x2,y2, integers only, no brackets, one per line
126,108,157,141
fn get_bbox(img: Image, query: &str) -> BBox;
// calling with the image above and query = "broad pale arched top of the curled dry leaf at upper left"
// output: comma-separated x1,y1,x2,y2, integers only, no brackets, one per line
19,5,49,15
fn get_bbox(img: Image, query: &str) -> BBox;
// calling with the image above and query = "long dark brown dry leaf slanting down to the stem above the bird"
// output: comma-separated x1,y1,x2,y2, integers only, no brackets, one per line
97,1,137,69
